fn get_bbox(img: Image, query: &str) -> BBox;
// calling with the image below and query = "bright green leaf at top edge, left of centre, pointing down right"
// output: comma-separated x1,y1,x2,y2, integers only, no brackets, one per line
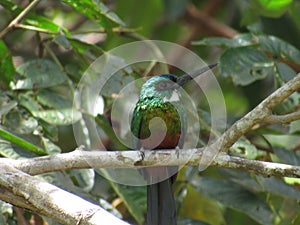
63,0,125,29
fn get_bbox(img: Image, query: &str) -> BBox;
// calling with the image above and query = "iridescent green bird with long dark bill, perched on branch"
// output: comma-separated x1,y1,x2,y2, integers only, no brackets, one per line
131,64,217,225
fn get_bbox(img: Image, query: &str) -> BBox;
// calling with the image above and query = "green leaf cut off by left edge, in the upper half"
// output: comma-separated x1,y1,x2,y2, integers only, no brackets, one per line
0,40,15,87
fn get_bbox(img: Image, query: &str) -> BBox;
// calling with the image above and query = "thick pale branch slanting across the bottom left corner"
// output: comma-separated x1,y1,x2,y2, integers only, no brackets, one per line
0,162,127,225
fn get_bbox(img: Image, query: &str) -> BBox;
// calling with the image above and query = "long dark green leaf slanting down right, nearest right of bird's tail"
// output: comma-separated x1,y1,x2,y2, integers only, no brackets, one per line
191,177,274,225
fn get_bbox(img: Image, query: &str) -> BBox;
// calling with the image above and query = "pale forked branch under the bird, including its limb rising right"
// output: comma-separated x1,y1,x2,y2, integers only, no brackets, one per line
0,74,300,177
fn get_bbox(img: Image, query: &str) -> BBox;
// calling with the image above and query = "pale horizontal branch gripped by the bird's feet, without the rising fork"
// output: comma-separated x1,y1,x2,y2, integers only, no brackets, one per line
0,149,300,178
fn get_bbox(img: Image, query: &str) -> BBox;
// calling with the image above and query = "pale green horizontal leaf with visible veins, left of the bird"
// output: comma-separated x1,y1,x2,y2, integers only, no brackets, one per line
31,108,81,125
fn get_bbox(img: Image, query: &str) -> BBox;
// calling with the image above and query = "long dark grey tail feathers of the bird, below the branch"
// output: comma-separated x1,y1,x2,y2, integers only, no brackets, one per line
146,177,177,225
